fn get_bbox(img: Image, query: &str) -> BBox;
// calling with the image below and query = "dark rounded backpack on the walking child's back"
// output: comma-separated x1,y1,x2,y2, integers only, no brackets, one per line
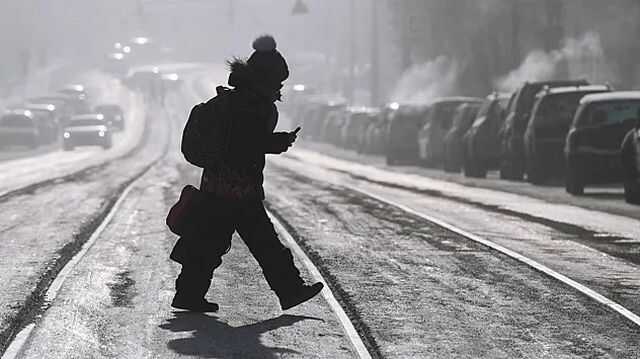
180,86,232,168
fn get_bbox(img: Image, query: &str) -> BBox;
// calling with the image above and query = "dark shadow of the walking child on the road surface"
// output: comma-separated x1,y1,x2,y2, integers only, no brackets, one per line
159,312,322,358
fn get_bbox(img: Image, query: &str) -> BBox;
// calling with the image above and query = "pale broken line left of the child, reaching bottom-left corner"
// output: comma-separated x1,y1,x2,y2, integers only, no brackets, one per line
2,174,142,359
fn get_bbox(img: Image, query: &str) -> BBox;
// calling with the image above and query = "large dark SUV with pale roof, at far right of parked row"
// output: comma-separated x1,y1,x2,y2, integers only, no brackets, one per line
564,91,640,195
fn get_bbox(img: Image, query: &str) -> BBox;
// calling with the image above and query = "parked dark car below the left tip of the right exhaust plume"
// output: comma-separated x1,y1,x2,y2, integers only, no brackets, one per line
463,92,510,177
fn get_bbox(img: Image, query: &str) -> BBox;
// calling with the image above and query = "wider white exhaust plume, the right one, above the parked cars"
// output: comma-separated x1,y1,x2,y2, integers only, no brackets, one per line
495,32,611,92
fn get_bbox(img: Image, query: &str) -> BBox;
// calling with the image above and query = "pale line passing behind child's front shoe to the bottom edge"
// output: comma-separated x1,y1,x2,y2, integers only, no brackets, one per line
268,211,371,359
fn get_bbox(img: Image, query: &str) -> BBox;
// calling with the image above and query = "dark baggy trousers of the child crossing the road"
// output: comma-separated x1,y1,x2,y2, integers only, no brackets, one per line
170,197,304,299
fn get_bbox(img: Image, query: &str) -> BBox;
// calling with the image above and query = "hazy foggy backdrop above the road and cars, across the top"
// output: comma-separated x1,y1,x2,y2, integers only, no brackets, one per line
0,0,640,105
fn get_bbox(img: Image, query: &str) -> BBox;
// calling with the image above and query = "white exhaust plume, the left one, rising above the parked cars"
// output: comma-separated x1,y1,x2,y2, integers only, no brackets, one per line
391,56,460,104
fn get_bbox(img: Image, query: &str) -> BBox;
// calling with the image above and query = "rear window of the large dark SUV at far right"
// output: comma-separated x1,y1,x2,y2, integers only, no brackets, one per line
576,100,640,126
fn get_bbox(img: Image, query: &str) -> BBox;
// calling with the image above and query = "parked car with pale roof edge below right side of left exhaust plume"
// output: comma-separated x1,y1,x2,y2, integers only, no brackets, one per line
418,97,482,166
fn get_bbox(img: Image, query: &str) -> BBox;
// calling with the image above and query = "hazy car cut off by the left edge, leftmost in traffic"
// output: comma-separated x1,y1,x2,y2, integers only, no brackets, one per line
0,110,41,148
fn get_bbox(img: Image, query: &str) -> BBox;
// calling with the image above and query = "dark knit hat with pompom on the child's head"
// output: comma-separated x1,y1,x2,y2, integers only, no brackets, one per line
247,35,289,83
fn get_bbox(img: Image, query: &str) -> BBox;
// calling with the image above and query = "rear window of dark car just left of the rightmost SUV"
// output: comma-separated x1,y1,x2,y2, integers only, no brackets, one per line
534,91,602,127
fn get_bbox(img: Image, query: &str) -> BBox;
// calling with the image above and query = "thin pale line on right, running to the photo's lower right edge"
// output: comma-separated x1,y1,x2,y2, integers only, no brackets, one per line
345,185,640,327
